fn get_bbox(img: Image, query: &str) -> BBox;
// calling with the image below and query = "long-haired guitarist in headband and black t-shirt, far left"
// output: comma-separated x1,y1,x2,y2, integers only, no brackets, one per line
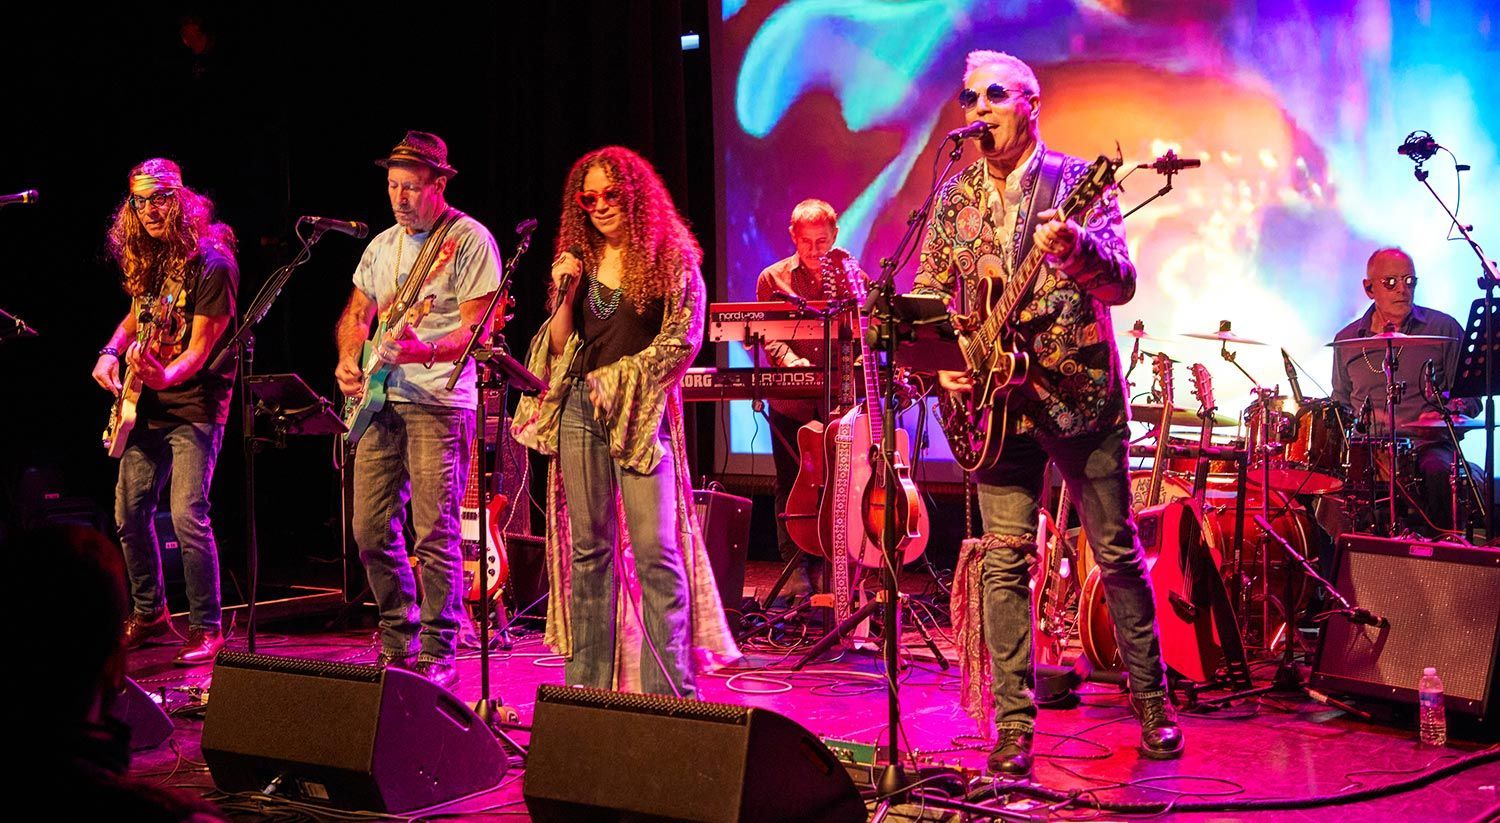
93,157,240,666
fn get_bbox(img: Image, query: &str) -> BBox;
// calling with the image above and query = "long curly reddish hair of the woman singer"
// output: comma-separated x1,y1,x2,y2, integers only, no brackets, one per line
554,145,704,312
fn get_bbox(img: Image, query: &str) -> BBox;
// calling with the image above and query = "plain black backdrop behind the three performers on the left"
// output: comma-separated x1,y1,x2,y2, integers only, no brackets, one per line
0,0,716,584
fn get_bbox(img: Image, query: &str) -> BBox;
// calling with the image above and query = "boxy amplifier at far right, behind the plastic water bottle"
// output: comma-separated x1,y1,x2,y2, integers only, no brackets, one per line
1311,535,1500,720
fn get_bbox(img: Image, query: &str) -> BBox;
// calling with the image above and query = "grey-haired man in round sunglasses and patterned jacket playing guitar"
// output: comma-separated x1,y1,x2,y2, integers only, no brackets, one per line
917,51,1184,777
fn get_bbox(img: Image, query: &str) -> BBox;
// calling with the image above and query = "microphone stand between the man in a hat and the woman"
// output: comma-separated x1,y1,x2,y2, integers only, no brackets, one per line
447,220,546,743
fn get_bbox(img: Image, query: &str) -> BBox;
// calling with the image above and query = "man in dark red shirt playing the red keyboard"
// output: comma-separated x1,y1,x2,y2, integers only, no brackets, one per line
756,199,870,598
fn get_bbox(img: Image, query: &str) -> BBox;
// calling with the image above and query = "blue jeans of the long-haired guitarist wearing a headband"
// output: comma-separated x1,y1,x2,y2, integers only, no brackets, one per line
114,420,224,631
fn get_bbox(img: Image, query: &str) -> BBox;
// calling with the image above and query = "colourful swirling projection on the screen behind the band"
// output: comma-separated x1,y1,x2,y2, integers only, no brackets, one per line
716,0,1500,477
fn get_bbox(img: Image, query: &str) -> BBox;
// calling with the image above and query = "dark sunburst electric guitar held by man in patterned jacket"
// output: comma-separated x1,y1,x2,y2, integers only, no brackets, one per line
938,156,1121,472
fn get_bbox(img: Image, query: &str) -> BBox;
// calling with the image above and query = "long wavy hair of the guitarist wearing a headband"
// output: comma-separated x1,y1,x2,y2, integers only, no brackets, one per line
108,157,236,297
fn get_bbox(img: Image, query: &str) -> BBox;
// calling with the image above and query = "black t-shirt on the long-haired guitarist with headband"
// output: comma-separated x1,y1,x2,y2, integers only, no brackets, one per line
138,249,240,423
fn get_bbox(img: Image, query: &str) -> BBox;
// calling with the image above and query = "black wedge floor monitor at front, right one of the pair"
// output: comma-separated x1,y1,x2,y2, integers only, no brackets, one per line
522,685,866,823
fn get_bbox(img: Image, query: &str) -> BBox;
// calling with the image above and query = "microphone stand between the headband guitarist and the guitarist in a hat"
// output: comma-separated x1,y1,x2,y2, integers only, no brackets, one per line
209,220,337,654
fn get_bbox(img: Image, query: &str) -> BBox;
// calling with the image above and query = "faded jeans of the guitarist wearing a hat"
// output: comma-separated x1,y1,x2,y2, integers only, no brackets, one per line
354,402,474,663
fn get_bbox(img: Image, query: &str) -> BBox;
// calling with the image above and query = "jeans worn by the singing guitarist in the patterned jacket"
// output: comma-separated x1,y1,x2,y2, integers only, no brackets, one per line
977,426,1167,730
